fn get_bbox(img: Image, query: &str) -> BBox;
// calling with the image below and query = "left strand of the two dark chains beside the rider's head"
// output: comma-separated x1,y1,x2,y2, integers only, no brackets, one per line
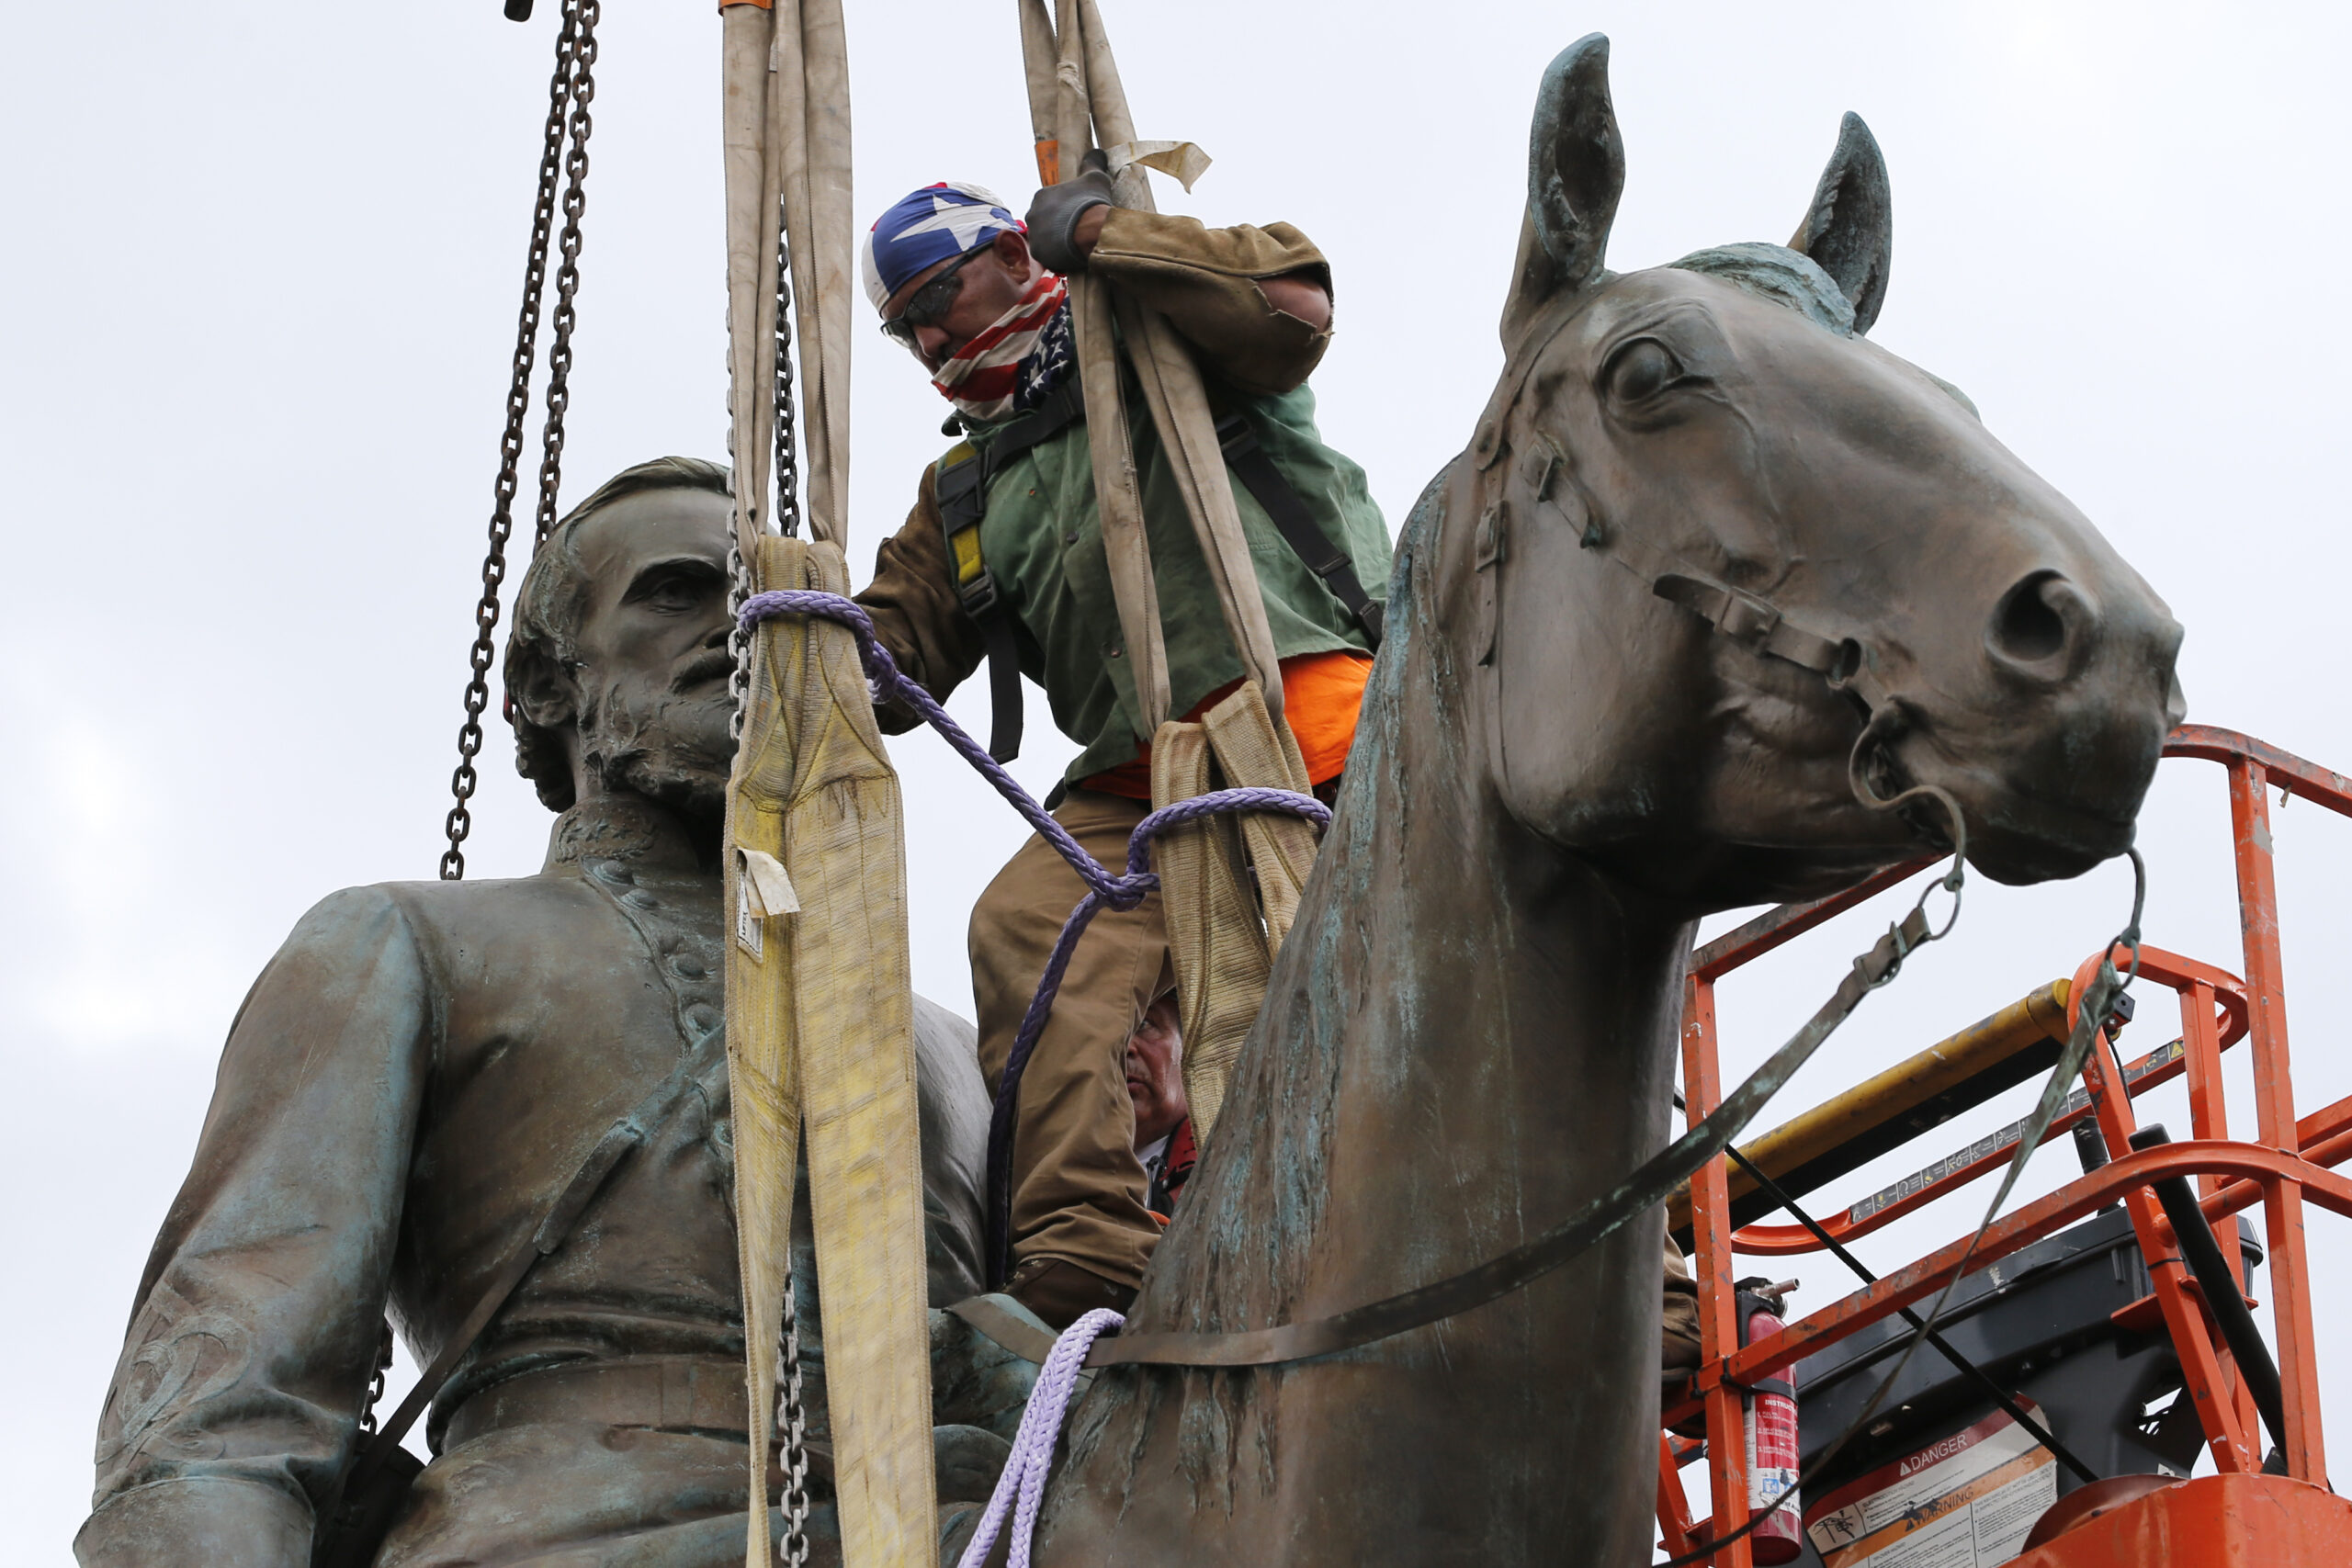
440,0,595,882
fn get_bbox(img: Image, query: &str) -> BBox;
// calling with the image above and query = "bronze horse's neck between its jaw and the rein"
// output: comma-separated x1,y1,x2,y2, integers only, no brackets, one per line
1146,510,1689,1328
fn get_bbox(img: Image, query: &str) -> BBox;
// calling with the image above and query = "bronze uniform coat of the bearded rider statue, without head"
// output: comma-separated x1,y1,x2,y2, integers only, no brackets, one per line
75,802,988,1568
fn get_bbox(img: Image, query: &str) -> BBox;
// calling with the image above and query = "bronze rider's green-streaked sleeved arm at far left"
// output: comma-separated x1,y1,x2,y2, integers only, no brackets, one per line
75,888,433,1568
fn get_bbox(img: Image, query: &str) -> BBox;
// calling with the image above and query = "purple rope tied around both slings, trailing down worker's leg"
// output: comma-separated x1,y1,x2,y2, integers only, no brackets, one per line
741,588,1331,1288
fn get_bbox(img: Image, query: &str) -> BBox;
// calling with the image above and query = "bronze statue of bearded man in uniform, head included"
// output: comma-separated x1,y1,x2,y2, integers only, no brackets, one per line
75,458,1028,1568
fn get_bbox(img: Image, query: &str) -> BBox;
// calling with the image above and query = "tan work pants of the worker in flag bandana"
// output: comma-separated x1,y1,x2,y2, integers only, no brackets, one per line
971,790,1171,1288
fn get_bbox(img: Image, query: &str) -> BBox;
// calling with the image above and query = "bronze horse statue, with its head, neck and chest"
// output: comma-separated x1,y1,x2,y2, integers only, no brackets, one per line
1037,35,2180,1568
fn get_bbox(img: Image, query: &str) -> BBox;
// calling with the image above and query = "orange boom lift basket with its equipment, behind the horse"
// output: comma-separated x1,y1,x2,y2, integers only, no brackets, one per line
1658,724,2352,1568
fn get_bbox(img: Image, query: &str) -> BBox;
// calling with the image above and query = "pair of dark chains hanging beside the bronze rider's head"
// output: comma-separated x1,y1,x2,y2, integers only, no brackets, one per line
440,0,600,882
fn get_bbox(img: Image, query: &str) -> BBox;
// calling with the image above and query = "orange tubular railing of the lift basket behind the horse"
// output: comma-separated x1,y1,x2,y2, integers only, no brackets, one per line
1658,724,2352,1568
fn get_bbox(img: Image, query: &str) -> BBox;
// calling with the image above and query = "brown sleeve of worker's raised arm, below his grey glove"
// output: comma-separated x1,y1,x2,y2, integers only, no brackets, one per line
1087,207,1331,392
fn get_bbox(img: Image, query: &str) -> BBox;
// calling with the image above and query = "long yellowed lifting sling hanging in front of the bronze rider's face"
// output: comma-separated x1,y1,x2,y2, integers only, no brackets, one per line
719,0,938,1568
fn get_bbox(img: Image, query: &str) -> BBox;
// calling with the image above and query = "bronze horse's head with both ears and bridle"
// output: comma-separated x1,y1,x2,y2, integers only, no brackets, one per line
1467,38,2180,908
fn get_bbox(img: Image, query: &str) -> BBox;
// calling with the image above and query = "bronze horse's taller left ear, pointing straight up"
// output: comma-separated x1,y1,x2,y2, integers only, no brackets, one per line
1503,33,1625,348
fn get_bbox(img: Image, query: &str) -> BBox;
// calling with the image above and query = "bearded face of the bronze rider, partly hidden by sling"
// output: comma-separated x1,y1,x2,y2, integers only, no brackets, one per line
571,489,734,831
